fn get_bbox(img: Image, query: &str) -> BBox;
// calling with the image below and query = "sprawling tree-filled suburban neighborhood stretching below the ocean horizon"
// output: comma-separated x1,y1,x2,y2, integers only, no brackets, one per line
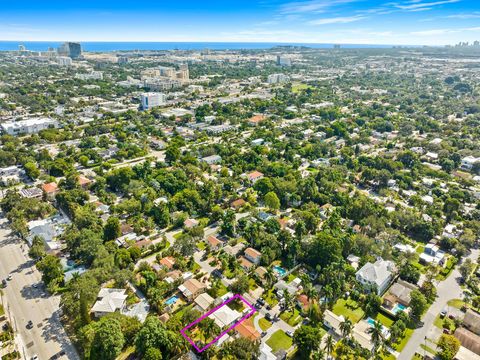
0,31,480,360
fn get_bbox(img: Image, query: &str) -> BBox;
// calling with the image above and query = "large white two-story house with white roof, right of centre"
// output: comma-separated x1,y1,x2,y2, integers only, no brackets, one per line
355,258,395,295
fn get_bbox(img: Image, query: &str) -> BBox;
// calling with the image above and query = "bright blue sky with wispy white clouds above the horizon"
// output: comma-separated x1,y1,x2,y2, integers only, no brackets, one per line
0,0,480,45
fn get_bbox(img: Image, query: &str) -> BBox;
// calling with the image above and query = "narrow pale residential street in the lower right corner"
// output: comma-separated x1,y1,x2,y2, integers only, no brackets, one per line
398,249,480,360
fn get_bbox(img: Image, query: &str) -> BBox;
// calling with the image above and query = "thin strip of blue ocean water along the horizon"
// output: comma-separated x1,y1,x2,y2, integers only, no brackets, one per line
0,41,392,52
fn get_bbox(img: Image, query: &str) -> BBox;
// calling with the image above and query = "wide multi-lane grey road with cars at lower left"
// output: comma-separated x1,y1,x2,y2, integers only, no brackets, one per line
0,215,79,360
